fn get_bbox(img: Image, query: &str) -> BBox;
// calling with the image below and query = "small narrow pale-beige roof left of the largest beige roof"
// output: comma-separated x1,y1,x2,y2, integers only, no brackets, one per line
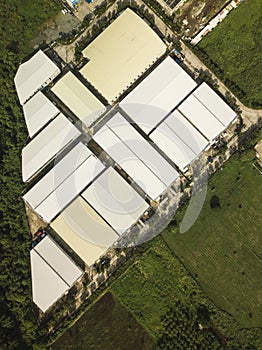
52,72,105,125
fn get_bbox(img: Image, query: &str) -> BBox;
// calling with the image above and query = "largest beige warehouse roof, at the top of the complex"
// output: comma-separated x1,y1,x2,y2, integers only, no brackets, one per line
80,9,166,102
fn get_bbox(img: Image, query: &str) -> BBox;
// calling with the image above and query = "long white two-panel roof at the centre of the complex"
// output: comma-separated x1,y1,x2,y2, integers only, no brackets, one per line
93,113,178,200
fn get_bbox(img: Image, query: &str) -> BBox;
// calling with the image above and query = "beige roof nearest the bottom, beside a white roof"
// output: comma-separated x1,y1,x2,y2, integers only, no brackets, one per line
51,197,118,265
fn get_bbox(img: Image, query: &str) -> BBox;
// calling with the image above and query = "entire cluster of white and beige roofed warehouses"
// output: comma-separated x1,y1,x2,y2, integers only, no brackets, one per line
15,9,237,312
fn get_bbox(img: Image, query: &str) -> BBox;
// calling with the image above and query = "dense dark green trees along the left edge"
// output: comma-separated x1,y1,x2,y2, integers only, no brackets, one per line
0,0,59,350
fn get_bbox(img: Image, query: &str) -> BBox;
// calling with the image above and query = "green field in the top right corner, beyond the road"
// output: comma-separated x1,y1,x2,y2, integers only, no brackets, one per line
197,0,262,108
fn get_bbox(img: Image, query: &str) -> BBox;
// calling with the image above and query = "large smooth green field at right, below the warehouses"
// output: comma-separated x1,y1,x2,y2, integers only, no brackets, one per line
163,151,262,328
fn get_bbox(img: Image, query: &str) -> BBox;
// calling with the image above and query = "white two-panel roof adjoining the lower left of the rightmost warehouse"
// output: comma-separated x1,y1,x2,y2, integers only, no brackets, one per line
150,110,208,171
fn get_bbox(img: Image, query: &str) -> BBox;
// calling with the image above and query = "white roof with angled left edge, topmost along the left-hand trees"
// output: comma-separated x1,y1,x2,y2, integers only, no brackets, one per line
15,50,60,104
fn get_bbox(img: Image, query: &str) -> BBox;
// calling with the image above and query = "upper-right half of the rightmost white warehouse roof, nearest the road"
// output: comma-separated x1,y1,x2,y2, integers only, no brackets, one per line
193,83,237,127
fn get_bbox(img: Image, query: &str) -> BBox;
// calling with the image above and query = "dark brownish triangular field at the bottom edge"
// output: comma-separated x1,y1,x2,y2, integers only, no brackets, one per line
52,293,156,350
